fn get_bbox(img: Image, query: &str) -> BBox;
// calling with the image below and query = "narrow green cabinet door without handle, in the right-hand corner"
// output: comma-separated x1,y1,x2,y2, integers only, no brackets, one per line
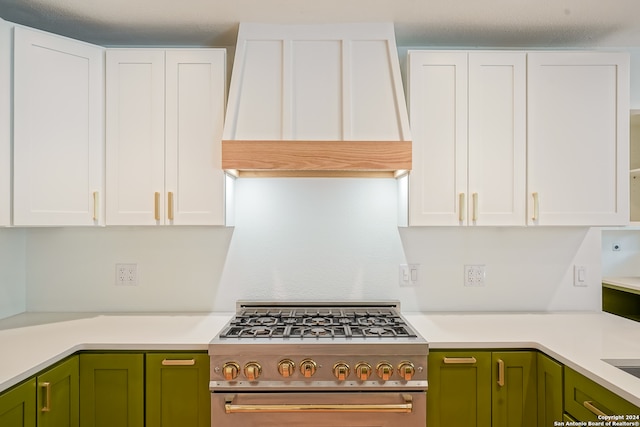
537,353,564,427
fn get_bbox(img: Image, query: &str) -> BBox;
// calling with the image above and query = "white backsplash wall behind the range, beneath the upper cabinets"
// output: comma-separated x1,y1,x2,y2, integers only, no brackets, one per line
0,0,639,426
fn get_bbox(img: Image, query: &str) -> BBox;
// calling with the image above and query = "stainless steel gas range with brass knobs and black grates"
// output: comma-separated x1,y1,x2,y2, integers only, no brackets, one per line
209,301,429,427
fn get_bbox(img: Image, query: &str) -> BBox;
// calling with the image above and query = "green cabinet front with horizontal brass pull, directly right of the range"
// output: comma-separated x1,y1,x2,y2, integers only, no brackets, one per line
427,350,491,427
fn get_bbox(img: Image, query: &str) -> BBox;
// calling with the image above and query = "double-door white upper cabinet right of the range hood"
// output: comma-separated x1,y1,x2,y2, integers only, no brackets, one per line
408,51,526,226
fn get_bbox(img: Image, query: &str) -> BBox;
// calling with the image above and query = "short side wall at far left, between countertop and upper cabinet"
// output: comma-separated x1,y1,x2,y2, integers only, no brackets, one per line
0,228,26,319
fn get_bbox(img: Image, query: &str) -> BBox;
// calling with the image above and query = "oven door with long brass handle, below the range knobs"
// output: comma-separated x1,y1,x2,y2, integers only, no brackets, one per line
211,391,427,427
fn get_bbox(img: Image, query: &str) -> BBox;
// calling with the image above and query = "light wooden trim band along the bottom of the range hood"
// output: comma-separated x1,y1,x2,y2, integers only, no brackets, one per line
222,140,411,177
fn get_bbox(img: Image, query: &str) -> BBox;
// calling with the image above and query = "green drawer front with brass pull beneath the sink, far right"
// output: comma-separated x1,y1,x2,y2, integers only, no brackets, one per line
564,366,640,421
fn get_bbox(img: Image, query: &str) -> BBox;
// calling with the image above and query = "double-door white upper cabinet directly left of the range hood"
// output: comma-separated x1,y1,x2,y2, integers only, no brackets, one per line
106,49,226,225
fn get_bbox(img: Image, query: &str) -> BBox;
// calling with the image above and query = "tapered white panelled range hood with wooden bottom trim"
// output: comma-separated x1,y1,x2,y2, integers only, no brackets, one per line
222,23,411,177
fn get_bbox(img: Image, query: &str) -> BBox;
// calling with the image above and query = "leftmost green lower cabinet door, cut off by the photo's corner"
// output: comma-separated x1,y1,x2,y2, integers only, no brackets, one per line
0,378,36,427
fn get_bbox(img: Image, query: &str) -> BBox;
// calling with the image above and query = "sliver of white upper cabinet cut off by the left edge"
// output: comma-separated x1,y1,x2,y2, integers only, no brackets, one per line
0,19,13,227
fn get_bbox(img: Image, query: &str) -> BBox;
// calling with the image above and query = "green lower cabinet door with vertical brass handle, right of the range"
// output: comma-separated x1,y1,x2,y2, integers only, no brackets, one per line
491,351,538,427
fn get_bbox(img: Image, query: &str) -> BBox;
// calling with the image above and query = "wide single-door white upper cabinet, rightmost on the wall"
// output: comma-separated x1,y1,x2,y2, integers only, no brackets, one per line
527,52,629,225
